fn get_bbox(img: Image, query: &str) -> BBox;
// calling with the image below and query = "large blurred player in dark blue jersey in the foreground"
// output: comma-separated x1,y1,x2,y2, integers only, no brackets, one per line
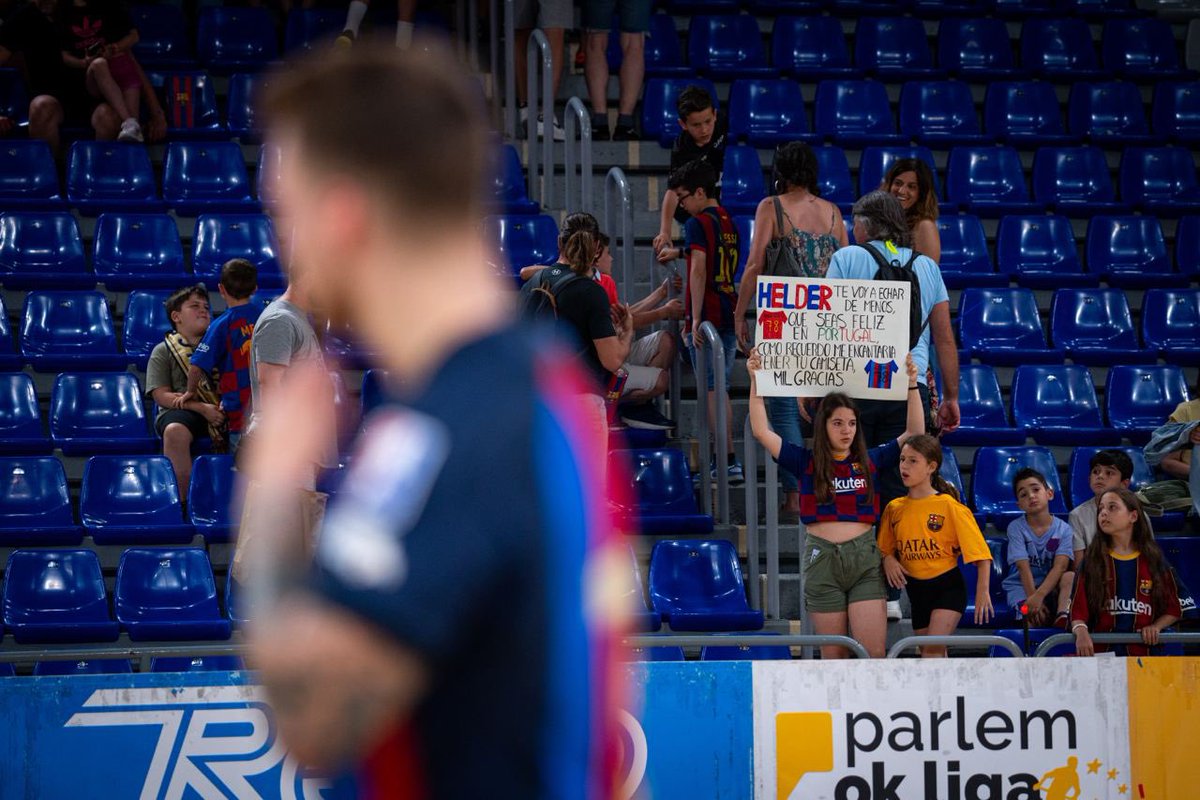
240,47,628,798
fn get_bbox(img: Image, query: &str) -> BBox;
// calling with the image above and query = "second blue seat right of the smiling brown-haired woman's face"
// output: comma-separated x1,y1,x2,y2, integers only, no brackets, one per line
1033,148,1129,217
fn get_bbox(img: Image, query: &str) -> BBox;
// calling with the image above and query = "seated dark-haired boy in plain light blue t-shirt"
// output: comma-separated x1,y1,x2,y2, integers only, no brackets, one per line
1002,467,1075,627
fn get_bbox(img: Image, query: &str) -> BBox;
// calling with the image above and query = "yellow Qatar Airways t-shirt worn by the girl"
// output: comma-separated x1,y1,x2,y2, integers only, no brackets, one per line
880,494,991,581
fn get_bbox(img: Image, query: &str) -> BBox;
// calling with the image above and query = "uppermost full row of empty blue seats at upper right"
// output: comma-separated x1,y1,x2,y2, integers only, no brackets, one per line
633,13,1193,83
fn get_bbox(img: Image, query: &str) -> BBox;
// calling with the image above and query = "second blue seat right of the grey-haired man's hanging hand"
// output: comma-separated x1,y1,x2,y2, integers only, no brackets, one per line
1013,365,1121,445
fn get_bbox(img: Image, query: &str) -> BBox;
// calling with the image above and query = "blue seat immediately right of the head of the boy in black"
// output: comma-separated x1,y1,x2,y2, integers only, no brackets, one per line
730,78,816,148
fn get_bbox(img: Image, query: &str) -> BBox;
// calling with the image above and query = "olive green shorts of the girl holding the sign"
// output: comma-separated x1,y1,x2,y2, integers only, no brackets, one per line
804,528,887,612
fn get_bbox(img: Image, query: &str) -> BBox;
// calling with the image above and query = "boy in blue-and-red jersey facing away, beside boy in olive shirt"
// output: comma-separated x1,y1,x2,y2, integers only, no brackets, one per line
185,258,262,453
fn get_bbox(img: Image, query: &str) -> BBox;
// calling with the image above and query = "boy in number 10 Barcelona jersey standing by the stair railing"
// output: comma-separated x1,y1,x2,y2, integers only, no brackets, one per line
660,155,744,485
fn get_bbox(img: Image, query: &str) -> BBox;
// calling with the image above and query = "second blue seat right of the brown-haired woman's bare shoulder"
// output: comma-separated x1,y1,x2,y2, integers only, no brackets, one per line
996,215,1099,289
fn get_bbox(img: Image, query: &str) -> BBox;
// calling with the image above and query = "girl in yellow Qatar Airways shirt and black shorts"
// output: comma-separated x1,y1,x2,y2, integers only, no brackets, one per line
880,434,994,658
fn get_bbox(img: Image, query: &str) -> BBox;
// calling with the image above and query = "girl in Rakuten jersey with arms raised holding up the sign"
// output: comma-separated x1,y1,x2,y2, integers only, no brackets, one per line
746,349,925,658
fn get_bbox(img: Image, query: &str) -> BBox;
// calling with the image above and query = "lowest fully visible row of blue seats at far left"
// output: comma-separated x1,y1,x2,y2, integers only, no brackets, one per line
4,547,236,644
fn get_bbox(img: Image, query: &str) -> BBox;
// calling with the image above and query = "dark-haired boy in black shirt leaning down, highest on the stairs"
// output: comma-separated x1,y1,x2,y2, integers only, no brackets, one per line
654,85,728,253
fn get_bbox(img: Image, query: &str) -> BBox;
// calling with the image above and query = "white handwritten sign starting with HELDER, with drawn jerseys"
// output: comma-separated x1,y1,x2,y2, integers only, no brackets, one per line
755,277,910,399
